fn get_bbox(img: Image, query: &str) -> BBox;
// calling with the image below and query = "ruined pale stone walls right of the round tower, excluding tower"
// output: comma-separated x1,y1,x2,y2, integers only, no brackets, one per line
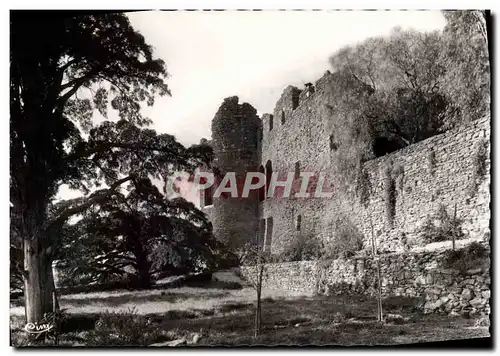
260,72,490,252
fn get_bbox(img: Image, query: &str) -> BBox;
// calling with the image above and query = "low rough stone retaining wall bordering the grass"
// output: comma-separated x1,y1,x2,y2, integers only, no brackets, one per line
241,245,491,315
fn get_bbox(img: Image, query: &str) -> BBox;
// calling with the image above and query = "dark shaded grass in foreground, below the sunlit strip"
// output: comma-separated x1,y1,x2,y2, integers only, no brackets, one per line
11,296,485,346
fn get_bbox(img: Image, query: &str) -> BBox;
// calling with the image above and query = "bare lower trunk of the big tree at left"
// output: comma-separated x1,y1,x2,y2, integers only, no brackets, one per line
24,237,54,323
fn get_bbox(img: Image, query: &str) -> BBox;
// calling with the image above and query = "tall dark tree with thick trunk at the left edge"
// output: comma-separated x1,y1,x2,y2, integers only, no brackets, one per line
10,11,212,322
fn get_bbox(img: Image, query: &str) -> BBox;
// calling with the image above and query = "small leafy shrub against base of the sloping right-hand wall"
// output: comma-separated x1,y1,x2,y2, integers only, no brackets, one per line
420,204,464,243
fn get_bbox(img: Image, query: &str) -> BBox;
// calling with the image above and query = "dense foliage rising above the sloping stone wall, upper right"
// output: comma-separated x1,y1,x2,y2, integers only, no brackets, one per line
326,11,490,183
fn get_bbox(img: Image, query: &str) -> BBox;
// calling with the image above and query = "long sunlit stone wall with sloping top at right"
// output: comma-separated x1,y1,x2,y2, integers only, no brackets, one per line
340,117,491,251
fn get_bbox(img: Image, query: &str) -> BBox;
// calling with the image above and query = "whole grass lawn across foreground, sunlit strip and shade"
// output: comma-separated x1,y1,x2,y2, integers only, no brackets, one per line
11,287,490,346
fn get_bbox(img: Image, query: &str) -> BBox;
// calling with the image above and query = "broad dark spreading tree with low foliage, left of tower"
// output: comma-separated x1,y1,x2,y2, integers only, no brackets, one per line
58,180,219,288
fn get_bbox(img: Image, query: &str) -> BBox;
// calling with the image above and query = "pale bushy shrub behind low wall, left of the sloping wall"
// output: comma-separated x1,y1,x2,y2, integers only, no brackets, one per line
323,217,363,259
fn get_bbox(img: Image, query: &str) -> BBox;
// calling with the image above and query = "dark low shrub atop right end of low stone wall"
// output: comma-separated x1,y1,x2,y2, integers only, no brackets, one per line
442,242,489,274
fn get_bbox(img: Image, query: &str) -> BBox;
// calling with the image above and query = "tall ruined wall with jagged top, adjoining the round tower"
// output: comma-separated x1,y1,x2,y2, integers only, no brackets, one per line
261,72,342,251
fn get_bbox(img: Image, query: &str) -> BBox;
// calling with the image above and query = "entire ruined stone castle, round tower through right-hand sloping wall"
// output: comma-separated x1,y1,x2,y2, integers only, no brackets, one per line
202,72,490,252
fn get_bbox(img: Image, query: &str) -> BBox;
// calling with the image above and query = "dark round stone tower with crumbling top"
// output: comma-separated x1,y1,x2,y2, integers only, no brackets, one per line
202,96,262,249
